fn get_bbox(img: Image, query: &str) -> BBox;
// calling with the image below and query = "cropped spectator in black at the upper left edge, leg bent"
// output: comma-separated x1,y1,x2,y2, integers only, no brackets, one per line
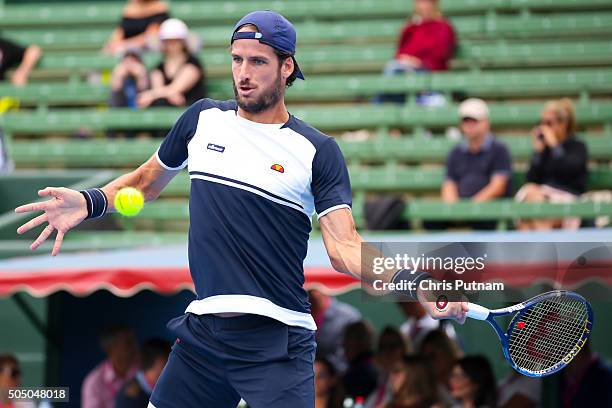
0,38,42,86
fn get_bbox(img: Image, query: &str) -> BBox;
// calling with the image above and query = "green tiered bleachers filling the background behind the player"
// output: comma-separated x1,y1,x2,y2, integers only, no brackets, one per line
0,0,612,253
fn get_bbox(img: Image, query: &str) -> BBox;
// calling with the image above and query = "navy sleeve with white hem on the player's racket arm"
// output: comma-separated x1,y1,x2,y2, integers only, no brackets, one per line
311,138,352,218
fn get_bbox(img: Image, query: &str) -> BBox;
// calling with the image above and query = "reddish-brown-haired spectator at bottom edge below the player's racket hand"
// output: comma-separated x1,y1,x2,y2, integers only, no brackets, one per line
377,356,442,408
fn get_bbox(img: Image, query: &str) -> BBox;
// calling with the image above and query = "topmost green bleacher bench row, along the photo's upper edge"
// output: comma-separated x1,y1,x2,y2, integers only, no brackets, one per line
0,0,612,27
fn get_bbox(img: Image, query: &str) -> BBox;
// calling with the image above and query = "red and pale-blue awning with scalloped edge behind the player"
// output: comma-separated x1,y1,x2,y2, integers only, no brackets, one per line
0,233,612,297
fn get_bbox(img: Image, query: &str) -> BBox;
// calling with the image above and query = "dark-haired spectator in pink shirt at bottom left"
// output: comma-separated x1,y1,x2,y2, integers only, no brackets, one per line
81,326,138,408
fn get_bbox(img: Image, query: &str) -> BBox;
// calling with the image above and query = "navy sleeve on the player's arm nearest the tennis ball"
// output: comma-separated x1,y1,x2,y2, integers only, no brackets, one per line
157,100,202,170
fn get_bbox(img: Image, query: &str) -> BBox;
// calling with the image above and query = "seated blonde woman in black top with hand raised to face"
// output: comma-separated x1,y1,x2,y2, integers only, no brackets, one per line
516,98,588,230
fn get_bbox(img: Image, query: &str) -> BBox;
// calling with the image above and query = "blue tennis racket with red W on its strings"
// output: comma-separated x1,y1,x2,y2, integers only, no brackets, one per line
467,290,593,377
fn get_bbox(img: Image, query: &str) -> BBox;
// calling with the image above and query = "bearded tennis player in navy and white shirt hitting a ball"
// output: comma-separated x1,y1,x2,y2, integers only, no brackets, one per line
16,11,467,408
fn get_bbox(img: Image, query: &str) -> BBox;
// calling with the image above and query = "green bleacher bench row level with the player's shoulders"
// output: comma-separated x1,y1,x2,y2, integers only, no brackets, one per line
0,102,612,134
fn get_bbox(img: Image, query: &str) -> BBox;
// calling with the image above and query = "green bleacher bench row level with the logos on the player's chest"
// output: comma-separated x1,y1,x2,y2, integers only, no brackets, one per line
10,133,612,167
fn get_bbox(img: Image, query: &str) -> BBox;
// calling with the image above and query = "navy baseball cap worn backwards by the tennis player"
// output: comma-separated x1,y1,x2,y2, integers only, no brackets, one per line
232,10,304,79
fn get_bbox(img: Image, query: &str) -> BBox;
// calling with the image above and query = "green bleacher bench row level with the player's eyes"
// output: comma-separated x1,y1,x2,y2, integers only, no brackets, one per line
26,40,612,78
